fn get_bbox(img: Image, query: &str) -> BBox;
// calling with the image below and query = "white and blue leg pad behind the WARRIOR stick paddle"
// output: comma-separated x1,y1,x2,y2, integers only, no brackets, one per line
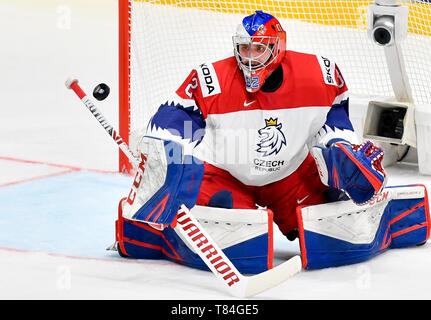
116,199,273,274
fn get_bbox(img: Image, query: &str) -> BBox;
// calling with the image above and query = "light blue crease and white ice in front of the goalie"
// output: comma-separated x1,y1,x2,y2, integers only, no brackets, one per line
0,164,431,300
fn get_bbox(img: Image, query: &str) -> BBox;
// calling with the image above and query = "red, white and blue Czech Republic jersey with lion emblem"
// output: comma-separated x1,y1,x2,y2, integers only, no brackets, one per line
149,51,357,186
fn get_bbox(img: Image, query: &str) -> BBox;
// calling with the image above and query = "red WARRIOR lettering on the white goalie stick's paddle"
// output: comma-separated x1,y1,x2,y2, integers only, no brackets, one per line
177,211,240,286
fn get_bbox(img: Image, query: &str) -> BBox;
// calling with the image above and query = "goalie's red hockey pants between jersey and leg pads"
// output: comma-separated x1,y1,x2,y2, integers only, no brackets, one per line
196,155,327,234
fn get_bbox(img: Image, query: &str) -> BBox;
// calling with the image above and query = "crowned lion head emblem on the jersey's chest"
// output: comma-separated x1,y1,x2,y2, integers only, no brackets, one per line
256,118,286,157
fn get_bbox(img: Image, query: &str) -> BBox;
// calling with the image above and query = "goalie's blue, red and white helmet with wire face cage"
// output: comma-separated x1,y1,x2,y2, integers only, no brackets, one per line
232,10,286,92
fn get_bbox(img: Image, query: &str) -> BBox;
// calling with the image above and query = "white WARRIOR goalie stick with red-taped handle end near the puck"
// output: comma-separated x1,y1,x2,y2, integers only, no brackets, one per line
66,78,302,297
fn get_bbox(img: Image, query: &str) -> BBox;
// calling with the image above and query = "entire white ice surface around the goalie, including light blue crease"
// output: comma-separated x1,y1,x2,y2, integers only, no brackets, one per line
0,0,431,300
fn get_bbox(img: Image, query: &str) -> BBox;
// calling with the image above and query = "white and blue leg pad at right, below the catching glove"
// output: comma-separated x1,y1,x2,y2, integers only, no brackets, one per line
297,186,430,269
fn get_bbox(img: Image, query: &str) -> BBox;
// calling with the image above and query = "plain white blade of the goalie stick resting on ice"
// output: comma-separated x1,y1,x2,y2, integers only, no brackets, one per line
243,256,302,297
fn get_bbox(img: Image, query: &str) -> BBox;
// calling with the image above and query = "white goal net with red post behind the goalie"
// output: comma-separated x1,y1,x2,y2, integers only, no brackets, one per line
118,0,431,172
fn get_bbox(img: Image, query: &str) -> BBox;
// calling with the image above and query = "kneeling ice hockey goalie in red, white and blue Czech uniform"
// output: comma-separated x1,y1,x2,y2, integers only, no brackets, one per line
110,11,429,273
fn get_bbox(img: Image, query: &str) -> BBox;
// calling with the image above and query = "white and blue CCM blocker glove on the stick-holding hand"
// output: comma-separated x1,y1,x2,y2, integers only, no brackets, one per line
123,137,204,225
